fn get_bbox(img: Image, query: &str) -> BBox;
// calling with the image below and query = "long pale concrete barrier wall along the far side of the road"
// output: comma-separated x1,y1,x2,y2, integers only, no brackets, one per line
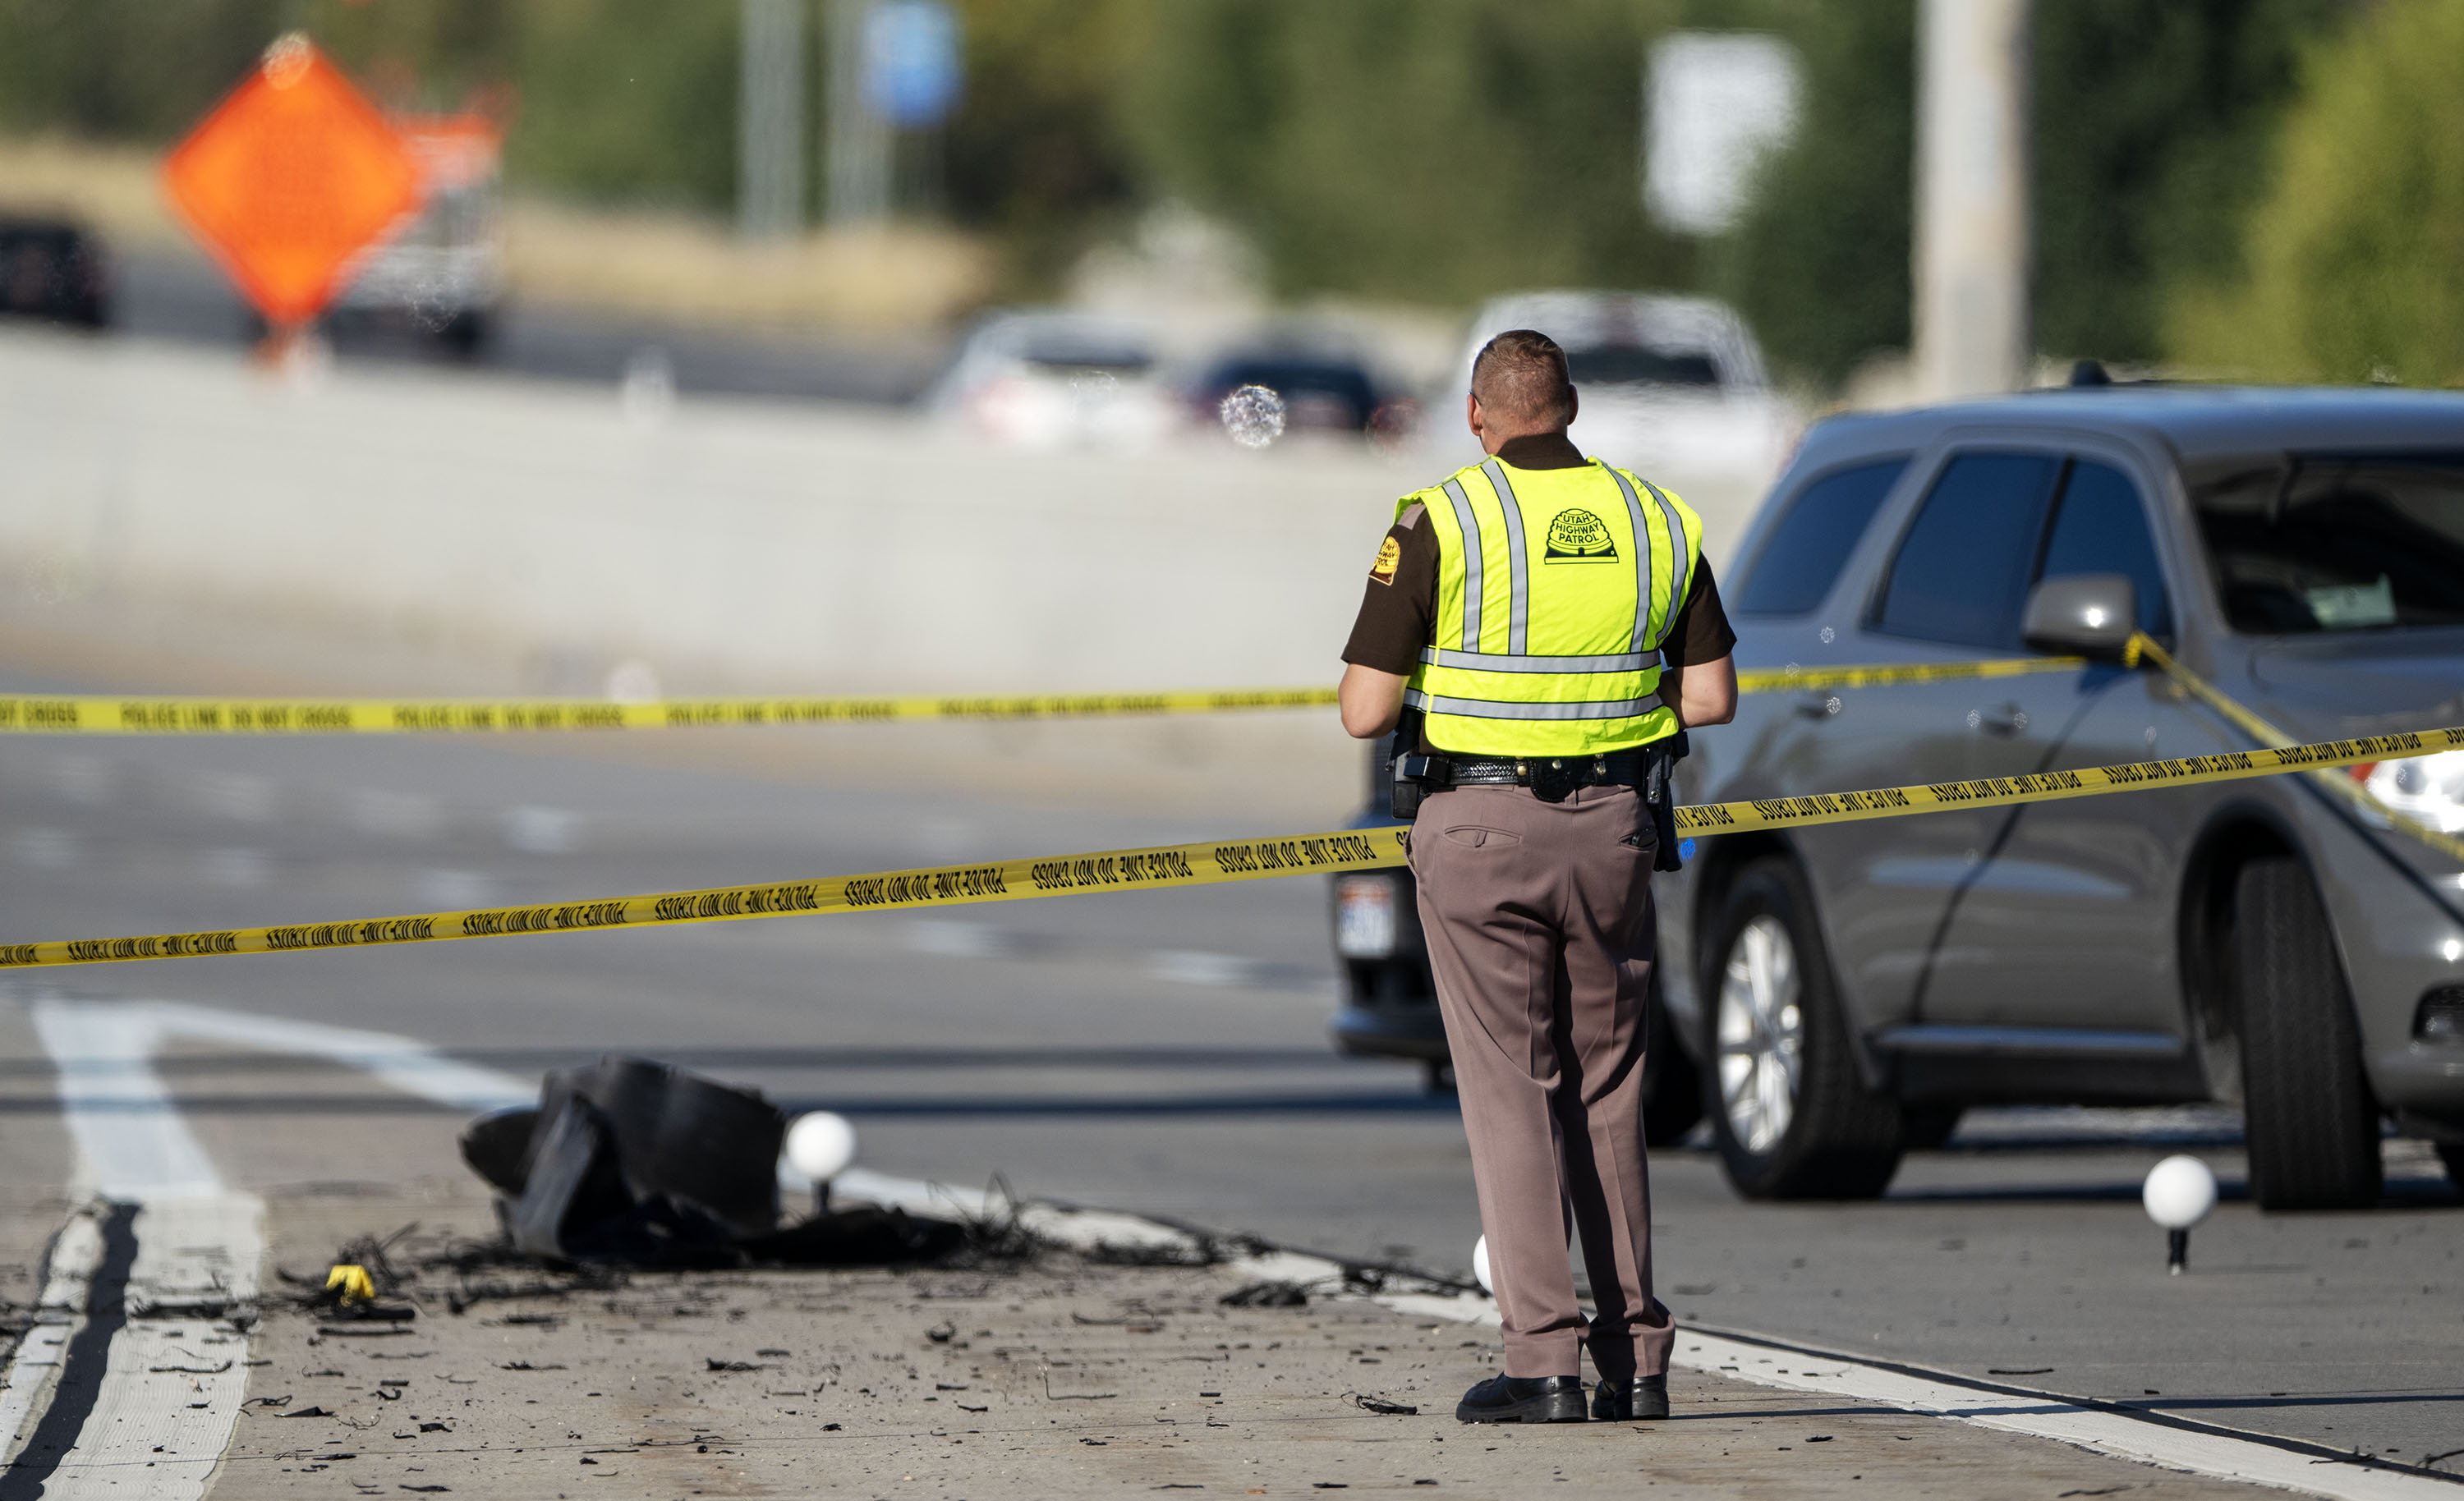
0,333,1749,798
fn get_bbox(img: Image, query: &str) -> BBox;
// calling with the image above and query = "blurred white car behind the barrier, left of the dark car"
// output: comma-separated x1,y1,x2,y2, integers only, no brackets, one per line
924,310,1180,448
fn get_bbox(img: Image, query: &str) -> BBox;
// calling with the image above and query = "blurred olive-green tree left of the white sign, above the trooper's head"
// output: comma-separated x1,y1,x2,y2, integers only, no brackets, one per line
1124,0,1690,303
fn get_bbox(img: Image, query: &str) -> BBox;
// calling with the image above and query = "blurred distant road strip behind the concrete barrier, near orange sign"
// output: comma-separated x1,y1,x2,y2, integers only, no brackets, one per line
113,251,944,404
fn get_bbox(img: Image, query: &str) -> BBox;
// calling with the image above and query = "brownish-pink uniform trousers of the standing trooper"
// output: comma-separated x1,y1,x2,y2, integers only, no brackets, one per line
1412,787,1676,1380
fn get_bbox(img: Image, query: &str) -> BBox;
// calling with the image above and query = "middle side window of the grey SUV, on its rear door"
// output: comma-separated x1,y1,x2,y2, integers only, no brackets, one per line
1875,453,2062,648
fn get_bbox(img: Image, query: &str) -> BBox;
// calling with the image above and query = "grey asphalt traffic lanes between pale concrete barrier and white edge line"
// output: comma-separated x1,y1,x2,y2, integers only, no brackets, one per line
0,655,2464,1471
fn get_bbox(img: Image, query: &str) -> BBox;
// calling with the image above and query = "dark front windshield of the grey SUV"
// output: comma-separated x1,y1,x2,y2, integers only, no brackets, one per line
2183,453,2464,626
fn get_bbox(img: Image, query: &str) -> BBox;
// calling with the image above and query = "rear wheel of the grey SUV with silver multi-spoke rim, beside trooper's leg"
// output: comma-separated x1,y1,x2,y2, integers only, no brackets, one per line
1703,861,1900,1198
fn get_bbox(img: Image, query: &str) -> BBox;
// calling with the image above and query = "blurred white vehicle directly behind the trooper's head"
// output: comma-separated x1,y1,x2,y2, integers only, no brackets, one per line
1432,291,1804,488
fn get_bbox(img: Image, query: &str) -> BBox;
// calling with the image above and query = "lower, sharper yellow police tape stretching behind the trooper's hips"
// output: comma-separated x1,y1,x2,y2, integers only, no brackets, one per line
0,727,2464,969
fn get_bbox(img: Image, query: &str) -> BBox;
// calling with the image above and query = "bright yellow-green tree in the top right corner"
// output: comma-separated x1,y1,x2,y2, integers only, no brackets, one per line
2171,0,2464,384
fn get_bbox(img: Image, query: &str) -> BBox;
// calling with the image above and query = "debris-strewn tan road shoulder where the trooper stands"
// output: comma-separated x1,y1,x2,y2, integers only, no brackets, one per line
214,1181,2252,1499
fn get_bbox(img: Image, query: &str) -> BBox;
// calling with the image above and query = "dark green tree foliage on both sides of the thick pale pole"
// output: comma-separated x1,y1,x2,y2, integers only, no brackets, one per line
1712,0,2348,379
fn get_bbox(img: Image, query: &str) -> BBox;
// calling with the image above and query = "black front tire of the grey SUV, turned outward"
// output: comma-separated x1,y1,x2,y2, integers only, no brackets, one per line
2232,856,2378,1210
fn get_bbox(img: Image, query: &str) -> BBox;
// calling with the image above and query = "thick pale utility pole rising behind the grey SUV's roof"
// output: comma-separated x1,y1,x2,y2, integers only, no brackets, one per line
1915,0,2035,399
